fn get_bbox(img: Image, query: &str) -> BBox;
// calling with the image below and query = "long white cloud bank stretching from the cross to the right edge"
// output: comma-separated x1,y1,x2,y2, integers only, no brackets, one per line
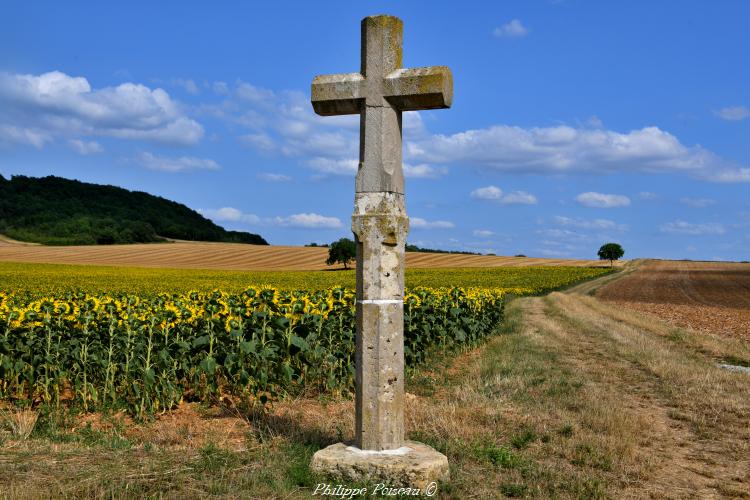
405,125,750,182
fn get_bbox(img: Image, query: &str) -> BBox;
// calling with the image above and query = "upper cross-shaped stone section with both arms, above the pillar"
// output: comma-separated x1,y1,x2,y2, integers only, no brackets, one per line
311,16,453,194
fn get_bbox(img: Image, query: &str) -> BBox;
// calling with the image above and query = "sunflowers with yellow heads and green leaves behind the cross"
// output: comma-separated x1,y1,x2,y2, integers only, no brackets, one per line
0,266,606,416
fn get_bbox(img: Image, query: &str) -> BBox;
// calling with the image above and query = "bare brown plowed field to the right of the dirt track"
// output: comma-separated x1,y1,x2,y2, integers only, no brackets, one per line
597,260,750,341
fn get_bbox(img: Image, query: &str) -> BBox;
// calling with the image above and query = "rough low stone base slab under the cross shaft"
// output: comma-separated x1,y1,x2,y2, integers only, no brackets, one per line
310,441,449,491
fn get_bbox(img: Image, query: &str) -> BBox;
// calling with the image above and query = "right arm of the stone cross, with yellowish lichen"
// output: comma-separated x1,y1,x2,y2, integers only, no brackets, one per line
384,66,453,111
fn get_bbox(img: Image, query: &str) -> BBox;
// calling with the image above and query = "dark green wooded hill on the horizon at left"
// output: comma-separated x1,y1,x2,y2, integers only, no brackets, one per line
0,175,268,245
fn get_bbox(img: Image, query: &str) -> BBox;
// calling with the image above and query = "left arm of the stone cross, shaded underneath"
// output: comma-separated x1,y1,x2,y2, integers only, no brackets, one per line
311,73,365,116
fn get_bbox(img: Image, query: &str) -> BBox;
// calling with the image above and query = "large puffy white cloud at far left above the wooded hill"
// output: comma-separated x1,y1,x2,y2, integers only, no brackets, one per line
0,71,204,146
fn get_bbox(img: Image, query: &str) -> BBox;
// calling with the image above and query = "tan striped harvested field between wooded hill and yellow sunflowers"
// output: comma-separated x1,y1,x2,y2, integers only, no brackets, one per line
0,238,602,271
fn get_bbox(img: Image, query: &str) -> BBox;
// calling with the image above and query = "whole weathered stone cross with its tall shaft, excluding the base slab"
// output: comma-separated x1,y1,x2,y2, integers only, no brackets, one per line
312,16,453,454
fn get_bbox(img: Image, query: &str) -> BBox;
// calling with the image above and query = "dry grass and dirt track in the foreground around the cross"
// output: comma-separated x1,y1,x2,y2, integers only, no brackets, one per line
0,272,750,499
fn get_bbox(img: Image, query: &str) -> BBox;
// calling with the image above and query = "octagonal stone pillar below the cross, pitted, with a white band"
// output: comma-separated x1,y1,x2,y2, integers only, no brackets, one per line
352,193,409,450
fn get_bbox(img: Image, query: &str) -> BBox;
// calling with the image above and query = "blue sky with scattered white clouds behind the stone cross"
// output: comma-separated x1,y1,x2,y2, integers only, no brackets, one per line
0,0,750,260
